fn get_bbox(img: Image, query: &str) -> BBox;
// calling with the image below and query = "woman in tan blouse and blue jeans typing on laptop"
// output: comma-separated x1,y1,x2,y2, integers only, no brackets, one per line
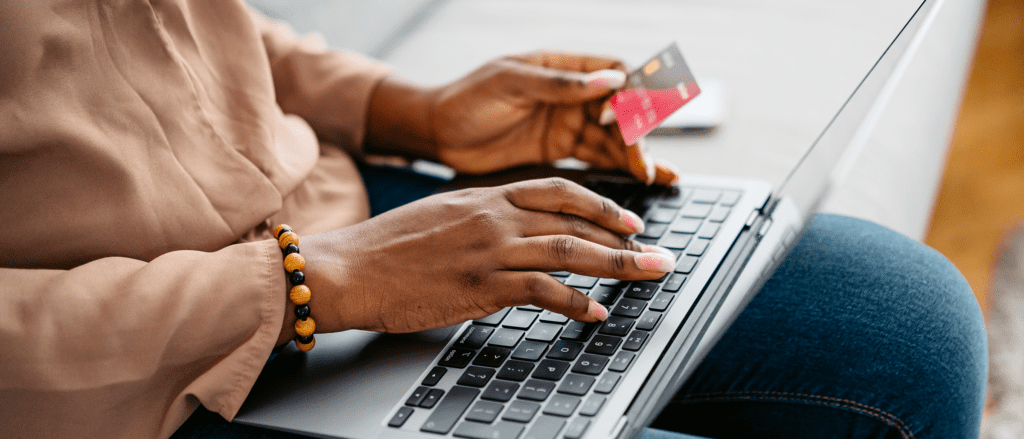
0,0,985,437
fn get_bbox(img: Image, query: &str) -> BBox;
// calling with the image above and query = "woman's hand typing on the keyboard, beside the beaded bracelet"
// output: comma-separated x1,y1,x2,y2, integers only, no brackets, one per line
282,178,675,341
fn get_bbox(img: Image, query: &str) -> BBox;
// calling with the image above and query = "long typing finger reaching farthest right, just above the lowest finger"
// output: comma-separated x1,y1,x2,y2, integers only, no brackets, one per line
502,234,676,279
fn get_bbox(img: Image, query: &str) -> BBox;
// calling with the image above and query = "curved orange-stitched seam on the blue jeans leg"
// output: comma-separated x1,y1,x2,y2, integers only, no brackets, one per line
676,391,914,439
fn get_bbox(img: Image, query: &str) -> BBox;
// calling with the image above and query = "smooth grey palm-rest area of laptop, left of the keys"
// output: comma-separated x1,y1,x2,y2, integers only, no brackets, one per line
236,326,459,439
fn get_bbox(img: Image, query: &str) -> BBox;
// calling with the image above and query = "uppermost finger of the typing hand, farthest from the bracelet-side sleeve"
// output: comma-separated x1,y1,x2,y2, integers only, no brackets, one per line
501,178,643,234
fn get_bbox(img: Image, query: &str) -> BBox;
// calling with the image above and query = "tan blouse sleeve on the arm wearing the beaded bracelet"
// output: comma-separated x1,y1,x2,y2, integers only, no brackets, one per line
0,239,287,438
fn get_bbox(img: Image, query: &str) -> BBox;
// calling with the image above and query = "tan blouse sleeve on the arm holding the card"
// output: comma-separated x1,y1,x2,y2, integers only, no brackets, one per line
251,11,388,156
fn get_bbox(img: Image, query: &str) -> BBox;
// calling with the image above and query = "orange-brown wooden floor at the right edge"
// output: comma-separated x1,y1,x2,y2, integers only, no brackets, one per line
926,0,1024,309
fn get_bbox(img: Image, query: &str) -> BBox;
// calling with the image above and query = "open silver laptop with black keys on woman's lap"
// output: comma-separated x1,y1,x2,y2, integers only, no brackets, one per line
234,0,942,439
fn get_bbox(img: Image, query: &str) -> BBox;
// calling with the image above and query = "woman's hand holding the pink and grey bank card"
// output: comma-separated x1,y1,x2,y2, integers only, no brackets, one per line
368,53,677,184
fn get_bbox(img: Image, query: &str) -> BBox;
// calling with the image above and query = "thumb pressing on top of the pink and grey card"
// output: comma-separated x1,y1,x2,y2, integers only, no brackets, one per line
510,64,626,104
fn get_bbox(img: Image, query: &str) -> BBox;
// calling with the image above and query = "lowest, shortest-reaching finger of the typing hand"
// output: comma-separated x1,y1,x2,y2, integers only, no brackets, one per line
500,271,608,321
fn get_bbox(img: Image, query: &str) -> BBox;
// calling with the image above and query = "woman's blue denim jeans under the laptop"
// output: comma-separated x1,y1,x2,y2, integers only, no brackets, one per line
175,163,987,439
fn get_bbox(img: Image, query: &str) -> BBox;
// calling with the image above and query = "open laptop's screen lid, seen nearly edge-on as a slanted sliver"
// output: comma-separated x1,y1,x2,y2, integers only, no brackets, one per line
769,0,942,220
